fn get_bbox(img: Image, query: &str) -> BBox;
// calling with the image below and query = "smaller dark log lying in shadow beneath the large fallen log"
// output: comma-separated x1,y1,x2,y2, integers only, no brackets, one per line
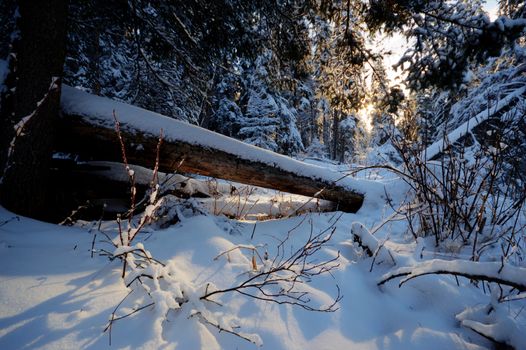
48,159,215,221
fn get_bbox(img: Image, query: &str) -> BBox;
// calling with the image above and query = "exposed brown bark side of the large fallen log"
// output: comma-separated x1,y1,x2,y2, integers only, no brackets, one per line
57,88,364,212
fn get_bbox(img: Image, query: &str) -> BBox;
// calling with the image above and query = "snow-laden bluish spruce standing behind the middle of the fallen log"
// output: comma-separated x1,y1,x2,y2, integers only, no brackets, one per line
208,52,304,154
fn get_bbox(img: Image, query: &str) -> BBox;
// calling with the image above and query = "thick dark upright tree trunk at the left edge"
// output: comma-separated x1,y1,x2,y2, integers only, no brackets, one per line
0,0,68,218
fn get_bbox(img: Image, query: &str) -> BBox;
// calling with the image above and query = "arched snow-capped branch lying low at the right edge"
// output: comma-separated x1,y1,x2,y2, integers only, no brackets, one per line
378,259,526,292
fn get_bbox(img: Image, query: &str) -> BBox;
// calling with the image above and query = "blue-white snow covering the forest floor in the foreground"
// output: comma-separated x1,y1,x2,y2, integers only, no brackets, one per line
0,167,526,349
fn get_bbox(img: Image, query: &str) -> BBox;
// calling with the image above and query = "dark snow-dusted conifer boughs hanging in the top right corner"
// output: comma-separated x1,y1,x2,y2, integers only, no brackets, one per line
366,0,526,91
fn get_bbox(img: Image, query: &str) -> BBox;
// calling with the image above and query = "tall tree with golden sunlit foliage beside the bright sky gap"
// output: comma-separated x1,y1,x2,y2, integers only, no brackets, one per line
314,1,370,161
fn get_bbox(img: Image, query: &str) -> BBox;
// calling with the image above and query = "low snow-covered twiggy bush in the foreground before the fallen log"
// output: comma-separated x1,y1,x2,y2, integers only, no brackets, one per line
105,208,342,345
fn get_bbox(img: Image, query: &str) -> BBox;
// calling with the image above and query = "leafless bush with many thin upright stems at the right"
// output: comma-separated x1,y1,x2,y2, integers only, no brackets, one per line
395,128,526,261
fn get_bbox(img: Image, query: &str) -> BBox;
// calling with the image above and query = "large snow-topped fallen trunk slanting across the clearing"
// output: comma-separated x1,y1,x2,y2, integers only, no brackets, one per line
57,86,372,212
